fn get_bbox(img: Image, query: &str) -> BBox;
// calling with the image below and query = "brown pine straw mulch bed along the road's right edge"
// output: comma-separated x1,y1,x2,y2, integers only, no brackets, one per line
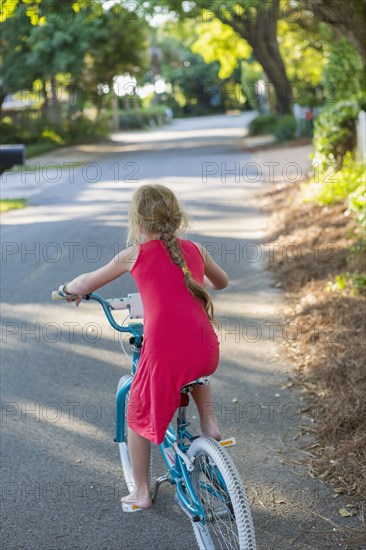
263,179,366,506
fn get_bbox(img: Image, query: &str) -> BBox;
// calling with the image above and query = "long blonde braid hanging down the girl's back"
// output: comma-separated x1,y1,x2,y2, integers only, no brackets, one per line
161,224,218,328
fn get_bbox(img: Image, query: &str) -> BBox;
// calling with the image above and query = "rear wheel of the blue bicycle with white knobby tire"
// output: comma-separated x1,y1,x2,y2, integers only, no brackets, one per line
187,436,256,550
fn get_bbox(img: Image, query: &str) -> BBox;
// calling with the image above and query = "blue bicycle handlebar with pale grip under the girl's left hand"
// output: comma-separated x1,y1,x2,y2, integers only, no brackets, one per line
52,290,143,338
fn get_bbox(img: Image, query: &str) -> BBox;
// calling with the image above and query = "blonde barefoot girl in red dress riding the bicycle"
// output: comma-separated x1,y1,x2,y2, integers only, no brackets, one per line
62,185,228,511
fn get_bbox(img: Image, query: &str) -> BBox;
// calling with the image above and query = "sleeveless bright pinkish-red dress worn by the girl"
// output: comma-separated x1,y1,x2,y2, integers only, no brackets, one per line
127,239,220,444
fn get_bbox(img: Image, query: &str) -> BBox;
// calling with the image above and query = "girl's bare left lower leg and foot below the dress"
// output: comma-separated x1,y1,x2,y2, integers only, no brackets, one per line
122,428,152,508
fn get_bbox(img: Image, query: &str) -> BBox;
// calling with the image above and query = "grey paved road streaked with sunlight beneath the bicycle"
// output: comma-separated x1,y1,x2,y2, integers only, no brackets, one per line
2,114,360,550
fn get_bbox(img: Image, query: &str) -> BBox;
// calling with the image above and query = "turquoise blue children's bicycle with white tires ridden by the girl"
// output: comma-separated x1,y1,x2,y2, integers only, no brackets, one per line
52,290,256,550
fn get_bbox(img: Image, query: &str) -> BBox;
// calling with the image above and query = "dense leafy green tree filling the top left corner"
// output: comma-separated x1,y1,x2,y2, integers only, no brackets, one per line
1,0,147,122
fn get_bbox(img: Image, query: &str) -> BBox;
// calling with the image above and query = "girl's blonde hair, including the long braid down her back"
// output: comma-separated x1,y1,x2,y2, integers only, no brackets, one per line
127,185,218,327
